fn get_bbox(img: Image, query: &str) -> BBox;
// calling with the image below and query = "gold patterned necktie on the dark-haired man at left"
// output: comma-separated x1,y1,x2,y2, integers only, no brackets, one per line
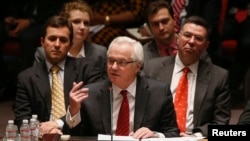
51,66,66,120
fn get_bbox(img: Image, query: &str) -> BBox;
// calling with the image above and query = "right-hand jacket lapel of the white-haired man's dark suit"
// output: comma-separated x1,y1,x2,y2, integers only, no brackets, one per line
134,76,149,131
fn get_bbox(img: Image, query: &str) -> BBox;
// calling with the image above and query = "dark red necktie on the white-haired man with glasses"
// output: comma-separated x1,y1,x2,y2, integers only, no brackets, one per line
116,90,129,136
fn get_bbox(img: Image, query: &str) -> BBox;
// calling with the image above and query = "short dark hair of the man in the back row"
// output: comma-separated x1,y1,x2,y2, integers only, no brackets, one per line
146,0,174,23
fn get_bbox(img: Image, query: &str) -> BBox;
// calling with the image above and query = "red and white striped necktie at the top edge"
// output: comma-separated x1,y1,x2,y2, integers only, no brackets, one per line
173,0,186,33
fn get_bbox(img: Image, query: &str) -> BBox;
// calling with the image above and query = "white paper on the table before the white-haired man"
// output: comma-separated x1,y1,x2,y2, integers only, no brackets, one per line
97,134,204,141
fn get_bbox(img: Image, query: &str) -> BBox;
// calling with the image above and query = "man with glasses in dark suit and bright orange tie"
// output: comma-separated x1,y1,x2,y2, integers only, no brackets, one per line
143,16,231,136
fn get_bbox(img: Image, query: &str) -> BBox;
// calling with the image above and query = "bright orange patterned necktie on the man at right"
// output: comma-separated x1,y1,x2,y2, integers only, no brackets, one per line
174,67,189,132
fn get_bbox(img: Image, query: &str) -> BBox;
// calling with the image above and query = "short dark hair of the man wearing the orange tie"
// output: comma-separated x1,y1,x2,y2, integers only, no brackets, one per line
181,15,211,39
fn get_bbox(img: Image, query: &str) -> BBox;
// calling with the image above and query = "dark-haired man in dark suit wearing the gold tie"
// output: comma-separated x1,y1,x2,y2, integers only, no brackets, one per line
14,16,103,133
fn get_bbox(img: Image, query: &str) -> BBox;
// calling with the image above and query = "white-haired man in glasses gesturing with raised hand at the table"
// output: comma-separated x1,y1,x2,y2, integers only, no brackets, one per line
64,36,179,138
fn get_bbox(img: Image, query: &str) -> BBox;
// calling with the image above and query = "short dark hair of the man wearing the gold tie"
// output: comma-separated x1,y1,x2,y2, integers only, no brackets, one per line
42,15,73,43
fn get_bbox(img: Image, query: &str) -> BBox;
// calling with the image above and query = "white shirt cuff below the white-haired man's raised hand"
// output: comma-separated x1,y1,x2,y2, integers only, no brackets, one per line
66,107,81,128
